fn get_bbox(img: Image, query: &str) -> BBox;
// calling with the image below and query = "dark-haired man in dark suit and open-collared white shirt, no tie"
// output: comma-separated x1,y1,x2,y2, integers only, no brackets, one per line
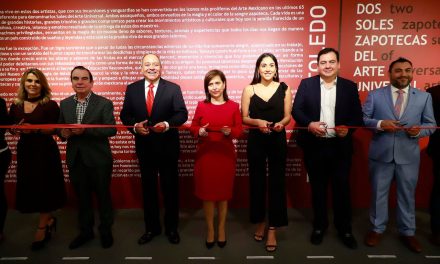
292,48,363,249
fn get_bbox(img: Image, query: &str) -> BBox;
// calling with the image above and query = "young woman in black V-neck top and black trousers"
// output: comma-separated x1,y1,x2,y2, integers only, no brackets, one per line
241,53,292,252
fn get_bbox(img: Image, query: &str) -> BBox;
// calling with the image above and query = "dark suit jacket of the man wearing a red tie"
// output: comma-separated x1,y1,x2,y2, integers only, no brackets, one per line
120,78,188,156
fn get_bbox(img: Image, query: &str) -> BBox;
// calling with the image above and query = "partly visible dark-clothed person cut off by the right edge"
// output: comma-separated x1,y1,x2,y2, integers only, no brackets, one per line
427,85,440,246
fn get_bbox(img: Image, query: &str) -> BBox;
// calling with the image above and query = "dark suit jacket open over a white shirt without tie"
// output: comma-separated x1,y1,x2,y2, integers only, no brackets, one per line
292,75,363,151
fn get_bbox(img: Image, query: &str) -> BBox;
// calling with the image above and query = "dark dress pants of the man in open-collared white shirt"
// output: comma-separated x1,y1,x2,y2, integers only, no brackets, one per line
303,138,352,234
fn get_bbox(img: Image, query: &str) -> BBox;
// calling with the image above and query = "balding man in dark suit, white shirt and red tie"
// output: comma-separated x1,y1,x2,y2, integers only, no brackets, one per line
120,54,188,244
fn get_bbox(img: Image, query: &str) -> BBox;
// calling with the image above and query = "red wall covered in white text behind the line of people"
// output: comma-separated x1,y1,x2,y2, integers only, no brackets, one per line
0,0,440,208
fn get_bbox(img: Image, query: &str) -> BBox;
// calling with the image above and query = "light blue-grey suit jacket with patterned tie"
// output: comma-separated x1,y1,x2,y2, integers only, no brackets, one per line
363,85,436,164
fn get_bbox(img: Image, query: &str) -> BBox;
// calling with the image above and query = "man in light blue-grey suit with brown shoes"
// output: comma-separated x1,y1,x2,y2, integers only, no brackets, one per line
363,58,436,253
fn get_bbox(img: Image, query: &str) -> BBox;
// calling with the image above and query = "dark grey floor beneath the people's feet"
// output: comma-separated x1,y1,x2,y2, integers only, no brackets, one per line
0,209,440,264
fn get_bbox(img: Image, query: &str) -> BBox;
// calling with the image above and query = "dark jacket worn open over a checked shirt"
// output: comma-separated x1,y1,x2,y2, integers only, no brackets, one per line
58,93,116,168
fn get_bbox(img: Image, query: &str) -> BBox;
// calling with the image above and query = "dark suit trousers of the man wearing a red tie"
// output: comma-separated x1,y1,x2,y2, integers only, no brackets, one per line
137,147,179,233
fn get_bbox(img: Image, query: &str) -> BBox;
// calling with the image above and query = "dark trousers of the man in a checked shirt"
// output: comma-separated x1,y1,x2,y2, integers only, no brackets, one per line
69,155,113,234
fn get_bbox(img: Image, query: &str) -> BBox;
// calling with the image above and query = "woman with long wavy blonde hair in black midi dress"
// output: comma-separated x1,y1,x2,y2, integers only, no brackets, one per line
9,69,66,250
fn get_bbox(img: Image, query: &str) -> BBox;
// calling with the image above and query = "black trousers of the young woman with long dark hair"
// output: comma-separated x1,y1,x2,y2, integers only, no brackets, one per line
247,130,287,227
